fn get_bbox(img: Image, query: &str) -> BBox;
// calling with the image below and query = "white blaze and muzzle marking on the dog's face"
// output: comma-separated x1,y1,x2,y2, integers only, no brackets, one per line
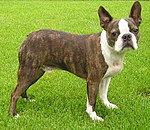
115,19,138,52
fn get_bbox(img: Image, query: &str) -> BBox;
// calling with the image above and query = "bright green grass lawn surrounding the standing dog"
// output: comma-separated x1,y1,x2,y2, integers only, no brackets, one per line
0,1,150,130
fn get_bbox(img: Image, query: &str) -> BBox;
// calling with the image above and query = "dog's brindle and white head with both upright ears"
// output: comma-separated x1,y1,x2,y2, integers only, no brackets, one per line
98,1,142,52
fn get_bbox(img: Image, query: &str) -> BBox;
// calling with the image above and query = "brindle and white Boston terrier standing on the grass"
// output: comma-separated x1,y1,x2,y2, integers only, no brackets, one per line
9,1,142,121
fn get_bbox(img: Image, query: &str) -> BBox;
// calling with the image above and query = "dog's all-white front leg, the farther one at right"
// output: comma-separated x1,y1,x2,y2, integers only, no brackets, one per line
99,77,118,109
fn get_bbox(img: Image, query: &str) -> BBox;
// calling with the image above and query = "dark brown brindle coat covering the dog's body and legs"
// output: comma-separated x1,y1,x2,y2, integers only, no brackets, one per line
10,30,108,115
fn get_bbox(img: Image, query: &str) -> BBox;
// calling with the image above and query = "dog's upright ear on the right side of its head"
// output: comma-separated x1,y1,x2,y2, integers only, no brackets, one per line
129,1,142,26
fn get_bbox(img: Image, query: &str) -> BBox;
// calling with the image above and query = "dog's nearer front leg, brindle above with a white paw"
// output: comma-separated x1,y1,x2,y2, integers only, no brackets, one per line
86,82,104,121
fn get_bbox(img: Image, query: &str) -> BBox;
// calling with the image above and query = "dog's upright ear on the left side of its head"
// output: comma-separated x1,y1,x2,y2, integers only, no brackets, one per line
98,6,113,30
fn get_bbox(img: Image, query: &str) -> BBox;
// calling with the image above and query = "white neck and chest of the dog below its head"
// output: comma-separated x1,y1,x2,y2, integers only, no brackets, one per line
100,30,125,77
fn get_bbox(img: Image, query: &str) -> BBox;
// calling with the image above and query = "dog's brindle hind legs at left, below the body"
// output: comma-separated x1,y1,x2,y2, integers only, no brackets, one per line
9,65,44,116
